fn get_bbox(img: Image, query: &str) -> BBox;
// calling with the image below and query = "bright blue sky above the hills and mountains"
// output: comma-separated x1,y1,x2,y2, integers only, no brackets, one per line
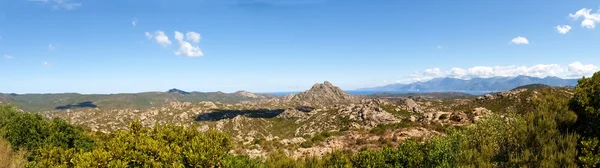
0,0,600,93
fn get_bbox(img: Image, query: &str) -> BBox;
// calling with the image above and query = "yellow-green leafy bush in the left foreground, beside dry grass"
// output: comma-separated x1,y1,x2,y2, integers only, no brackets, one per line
32,122,231,167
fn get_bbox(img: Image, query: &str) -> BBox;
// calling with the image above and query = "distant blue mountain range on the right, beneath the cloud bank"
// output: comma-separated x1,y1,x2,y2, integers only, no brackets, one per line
357,75,578,92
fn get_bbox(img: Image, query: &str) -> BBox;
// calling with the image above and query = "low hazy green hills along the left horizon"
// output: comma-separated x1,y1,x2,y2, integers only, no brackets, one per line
0,89,273,111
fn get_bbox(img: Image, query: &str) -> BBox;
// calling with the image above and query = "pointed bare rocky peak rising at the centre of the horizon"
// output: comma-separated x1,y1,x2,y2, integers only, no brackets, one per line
286,81,355,104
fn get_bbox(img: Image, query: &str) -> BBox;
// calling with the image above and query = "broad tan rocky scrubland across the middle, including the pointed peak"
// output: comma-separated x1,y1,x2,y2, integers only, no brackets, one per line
37,82,571,158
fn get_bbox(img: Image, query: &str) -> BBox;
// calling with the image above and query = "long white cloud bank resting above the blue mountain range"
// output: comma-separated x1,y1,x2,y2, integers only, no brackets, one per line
396,62,600,83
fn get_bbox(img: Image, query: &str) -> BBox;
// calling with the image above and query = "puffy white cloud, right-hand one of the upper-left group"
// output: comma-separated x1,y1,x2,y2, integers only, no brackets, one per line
175,31,204,57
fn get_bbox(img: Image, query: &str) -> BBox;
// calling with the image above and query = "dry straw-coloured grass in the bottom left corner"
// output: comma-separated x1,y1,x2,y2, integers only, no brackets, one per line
0,138,27,168
